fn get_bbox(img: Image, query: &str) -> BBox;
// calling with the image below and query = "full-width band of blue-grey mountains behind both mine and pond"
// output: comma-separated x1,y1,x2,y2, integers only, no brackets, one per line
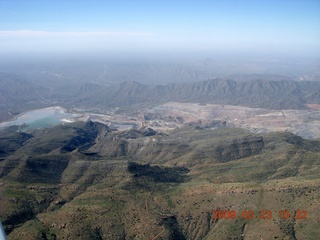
0,74,320,121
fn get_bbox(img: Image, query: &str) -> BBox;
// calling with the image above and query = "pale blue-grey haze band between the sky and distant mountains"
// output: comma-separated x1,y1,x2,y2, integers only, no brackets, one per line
0,53,320,86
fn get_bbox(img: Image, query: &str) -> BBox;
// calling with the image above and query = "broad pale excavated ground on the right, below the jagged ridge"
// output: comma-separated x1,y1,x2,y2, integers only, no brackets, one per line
145,102,320,139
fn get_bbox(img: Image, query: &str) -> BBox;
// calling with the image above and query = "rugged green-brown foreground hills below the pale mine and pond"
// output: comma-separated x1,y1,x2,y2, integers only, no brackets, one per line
0,122,320,239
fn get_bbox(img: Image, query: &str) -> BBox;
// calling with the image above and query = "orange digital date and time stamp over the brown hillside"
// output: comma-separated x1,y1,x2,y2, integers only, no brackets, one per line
212,209,308,220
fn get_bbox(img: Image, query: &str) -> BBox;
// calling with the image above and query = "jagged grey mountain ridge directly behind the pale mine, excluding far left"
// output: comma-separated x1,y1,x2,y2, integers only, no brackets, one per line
54,79,320,109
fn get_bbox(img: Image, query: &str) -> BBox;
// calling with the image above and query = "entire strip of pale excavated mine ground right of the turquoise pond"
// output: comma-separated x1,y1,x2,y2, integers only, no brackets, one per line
4,102,320,139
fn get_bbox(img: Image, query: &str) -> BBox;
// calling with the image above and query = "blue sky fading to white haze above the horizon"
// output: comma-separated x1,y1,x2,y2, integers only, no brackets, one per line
0,0,320,56
